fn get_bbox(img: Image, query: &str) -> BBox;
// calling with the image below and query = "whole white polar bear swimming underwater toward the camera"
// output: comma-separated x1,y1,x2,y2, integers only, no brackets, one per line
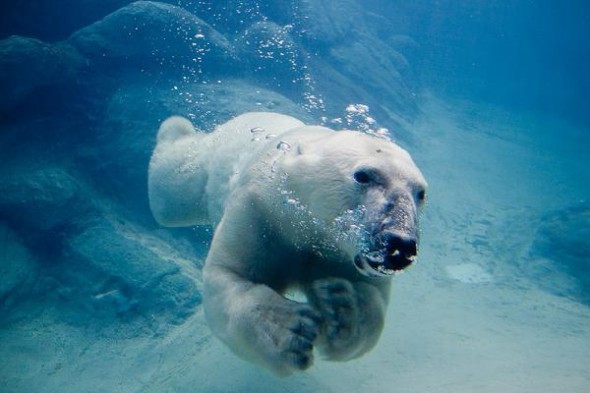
148,112,426,375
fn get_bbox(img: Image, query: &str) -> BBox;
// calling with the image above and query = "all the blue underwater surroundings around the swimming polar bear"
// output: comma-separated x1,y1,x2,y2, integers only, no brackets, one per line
0,0,590,393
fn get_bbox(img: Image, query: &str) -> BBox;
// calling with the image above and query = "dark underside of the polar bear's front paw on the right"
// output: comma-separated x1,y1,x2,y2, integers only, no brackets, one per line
309,278,360,360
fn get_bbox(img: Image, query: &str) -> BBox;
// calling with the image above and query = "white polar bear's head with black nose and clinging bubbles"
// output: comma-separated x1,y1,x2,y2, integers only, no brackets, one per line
281,127,427,277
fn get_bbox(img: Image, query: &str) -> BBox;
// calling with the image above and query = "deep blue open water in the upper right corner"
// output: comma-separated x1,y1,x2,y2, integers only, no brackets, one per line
390,0,590,126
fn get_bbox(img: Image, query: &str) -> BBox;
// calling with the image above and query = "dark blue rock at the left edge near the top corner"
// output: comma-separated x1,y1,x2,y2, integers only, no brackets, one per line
0,36,83,111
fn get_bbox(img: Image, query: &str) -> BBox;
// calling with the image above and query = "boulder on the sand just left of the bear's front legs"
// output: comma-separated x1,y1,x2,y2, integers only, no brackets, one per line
58,214,201,330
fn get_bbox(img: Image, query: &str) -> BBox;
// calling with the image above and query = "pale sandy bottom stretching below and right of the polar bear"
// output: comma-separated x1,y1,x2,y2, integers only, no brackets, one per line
0,98,590,393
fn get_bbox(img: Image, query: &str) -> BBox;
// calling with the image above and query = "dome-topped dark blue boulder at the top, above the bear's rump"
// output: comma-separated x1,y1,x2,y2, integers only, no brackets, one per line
68,1,238,71
